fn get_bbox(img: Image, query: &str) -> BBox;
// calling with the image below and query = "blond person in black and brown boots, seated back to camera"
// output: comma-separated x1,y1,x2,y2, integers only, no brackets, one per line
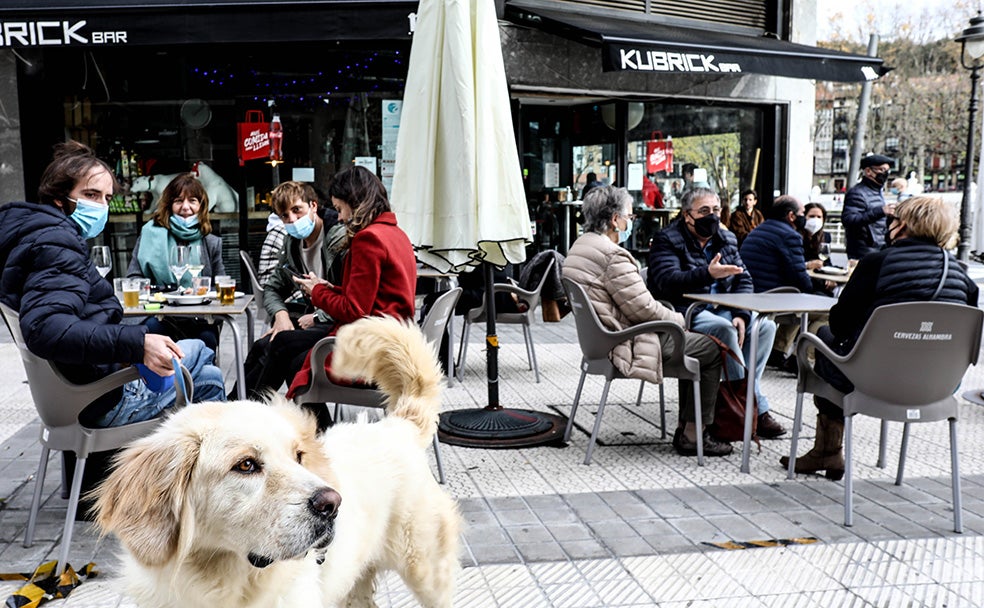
779,197,979,481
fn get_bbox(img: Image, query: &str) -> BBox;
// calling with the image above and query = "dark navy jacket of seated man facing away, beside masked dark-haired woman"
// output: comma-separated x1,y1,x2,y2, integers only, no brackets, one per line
739,219,813,293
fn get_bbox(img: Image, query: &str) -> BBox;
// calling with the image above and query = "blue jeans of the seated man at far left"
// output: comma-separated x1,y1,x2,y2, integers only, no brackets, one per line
95,340,226,428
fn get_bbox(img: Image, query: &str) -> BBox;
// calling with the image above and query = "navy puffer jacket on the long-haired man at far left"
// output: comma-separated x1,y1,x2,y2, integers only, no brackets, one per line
0,202,147,409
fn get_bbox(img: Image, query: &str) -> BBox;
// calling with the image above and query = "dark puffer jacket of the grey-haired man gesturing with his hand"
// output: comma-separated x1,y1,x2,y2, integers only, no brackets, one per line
646,217,752,322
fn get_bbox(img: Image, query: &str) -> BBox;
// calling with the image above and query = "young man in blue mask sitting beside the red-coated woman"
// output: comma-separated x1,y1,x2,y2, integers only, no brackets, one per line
230,181,345,408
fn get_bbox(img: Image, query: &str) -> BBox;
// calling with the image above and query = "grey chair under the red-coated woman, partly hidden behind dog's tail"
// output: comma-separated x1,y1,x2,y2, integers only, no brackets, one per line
294,287,461,484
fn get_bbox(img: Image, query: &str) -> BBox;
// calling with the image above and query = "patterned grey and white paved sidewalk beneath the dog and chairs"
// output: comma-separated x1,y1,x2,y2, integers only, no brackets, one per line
0,306,984,608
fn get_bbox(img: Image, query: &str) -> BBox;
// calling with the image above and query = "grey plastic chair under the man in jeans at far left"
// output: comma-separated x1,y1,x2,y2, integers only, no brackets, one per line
0,304,194,571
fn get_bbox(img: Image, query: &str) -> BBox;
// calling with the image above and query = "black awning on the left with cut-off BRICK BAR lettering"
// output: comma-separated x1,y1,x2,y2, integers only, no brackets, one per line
0,0,417,49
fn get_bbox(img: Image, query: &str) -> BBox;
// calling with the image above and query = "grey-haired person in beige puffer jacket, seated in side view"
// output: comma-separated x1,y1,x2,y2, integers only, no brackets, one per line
563,186,732,456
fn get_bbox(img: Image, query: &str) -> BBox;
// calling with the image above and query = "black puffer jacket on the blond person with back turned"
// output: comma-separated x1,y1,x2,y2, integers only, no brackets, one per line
830,238,978,344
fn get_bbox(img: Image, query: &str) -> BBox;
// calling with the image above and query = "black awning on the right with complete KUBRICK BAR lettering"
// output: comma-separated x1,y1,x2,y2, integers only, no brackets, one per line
506,3,889,82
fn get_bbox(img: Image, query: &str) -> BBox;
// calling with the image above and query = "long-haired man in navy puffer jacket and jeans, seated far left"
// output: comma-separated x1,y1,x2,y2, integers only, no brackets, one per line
0,142,225,513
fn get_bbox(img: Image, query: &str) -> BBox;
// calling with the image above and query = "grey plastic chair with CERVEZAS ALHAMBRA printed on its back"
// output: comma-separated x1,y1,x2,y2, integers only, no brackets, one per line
788,302,984,533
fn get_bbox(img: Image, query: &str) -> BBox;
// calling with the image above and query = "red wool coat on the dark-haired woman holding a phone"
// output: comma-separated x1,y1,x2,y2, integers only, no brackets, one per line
287,211,417,399
